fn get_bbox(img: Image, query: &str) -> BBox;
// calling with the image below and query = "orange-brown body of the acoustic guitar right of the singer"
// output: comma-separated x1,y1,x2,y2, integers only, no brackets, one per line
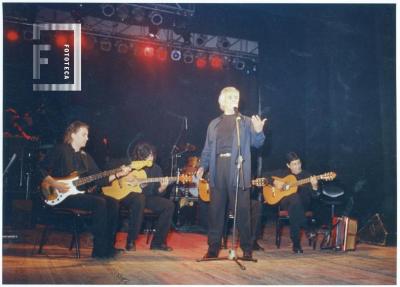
263,174,297,205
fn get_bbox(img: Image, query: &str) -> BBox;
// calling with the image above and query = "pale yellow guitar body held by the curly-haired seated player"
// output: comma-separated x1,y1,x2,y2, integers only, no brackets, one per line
102,170,147,200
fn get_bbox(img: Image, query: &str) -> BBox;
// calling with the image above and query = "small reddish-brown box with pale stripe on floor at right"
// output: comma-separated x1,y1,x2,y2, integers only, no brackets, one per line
332,216,357,251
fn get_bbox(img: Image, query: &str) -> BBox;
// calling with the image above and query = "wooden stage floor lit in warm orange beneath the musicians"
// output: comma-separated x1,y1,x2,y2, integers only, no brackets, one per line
2,226,396,285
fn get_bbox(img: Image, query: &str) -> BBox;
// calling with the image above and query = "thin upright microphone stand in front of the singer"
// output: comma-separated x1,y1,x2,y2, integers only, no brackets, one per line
197,113,257,270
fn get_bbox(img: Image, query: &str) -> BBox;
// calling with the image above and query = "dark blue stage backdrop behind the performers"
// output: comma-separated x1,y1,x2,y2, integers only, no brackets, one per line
3,4,396,233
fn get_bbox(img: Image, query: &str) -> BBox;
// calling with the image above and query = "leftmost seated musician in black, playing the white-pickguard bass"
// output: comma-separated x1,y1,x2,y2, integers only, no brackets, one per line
40,121,130,258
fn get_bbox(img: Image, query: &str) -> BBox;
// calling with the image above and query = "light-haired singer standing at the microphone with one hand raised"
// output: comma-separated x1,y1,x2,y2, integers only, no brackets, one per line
197,87,266,259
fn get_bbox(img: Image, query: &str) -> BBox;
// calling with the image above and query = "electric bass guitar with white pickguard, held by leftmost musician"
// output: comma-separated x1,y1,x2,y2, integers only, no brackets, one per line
42,160,153,206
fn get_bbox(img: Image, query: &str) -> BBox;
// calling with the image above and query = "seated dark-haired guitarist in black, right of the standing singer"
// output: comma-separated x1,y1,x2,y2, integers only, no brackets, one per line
263,152,318,253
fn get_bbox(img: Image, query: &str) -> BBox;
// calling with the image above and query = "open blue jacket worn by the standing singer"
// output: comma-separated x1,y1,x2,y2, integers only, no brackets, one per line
200,114,265,188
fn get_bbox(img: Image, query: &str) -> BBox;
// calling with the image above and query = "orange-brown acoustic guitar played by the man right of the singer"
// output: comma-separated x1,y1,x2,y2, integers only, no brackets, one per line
251,171,336,205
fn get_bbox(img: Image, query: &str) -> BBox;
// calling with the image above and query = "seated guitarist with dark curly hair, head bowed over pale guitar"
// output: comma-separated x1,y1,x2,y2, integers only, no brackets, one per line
121,142,175,251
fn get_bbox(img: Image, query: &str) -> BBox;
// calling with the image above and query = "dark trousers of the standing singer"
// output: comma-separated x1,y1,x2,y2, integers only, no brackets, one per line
208,157,251,251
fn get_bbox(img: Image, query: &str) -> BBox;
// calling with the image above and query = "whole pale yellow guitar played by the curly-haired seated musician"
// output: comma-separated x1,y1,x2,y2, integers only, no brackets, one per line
102,170,192,200
